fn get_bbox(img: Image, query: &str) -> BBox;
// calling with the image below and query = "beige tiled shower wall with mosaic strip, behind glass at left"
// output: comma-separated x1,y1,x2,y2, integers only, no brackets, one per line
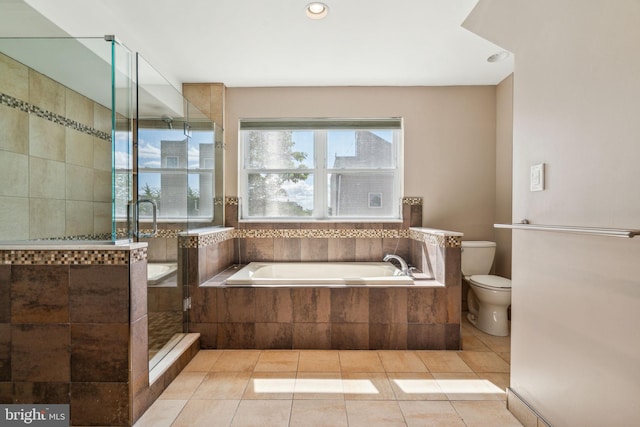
0,54,111,240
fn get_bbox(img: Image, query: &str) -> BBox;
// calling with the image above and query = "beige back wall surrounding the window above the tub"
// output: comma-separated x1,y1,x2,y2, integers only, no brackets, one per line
225,86,496,239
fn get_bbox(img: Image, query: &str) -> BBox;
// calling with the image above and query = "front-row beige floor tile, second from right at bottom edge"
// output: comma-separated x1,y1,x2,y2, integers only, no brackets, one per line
398,402,465,427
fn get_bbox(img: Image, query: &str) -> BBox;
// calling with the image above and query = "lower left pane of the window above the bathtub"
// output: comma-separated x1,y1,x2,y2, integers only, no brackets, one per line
246,172,313,217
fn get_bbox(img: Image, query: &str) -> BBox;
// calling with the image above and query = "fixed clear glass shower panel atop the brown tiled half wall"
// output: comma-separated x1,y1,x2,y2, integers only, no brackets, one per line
0,37,133,241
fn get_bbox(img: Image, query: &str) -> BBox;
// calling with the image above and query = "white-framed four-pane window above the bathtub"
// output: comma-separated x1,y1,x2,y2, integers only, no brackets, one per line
239,118,402,220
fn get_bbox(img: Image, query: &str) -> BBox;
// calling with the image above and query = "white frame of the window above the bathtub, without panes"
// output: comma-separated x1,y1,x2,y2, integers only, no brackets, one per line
238,118,404,222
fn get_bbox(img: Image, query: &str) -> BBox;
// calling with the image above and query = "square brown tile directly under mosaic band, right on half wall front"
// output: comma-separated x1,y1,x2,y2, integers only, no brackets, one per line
69,265,129,323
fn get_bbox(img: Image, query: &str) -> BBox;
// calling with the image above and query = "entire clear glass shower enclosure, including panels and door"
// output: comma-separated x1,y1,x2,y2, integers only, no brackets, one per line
0,36,222,367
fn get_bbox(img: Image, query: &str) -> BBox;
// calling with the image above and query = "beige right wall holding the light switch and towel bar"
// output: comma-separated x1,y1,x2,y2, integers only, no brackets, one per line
465,0,640,427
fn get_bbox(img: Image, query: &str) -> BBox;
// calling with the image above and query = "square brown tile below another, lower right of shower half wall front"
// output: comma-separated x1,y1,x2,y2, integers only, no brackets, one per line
71,323,129,382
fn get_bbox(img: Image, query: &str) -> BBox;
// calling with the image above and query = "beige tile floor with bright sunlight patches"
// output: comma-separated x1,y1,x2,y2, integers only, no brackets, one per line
135,321,521,427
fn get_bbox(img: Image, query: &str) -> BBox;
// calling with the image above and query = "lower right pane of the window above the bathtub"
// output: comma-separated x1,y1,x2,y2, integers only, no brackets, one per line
328,172,400,217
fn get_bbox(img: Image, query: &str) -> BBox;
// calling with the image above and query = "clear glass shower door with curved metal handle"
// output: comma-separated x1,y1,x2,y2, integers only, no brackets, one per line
134,54,191,368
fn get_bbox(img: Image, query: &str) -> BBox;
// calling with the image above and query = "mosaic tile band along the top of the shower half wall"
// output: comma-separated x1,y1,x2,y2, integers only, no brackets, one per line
0,248,132,265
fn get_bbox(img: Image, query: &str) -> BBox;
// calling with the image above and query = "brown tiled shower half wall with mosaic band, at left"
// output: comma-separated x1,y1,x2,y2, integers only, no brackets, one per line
0,243,193,426
